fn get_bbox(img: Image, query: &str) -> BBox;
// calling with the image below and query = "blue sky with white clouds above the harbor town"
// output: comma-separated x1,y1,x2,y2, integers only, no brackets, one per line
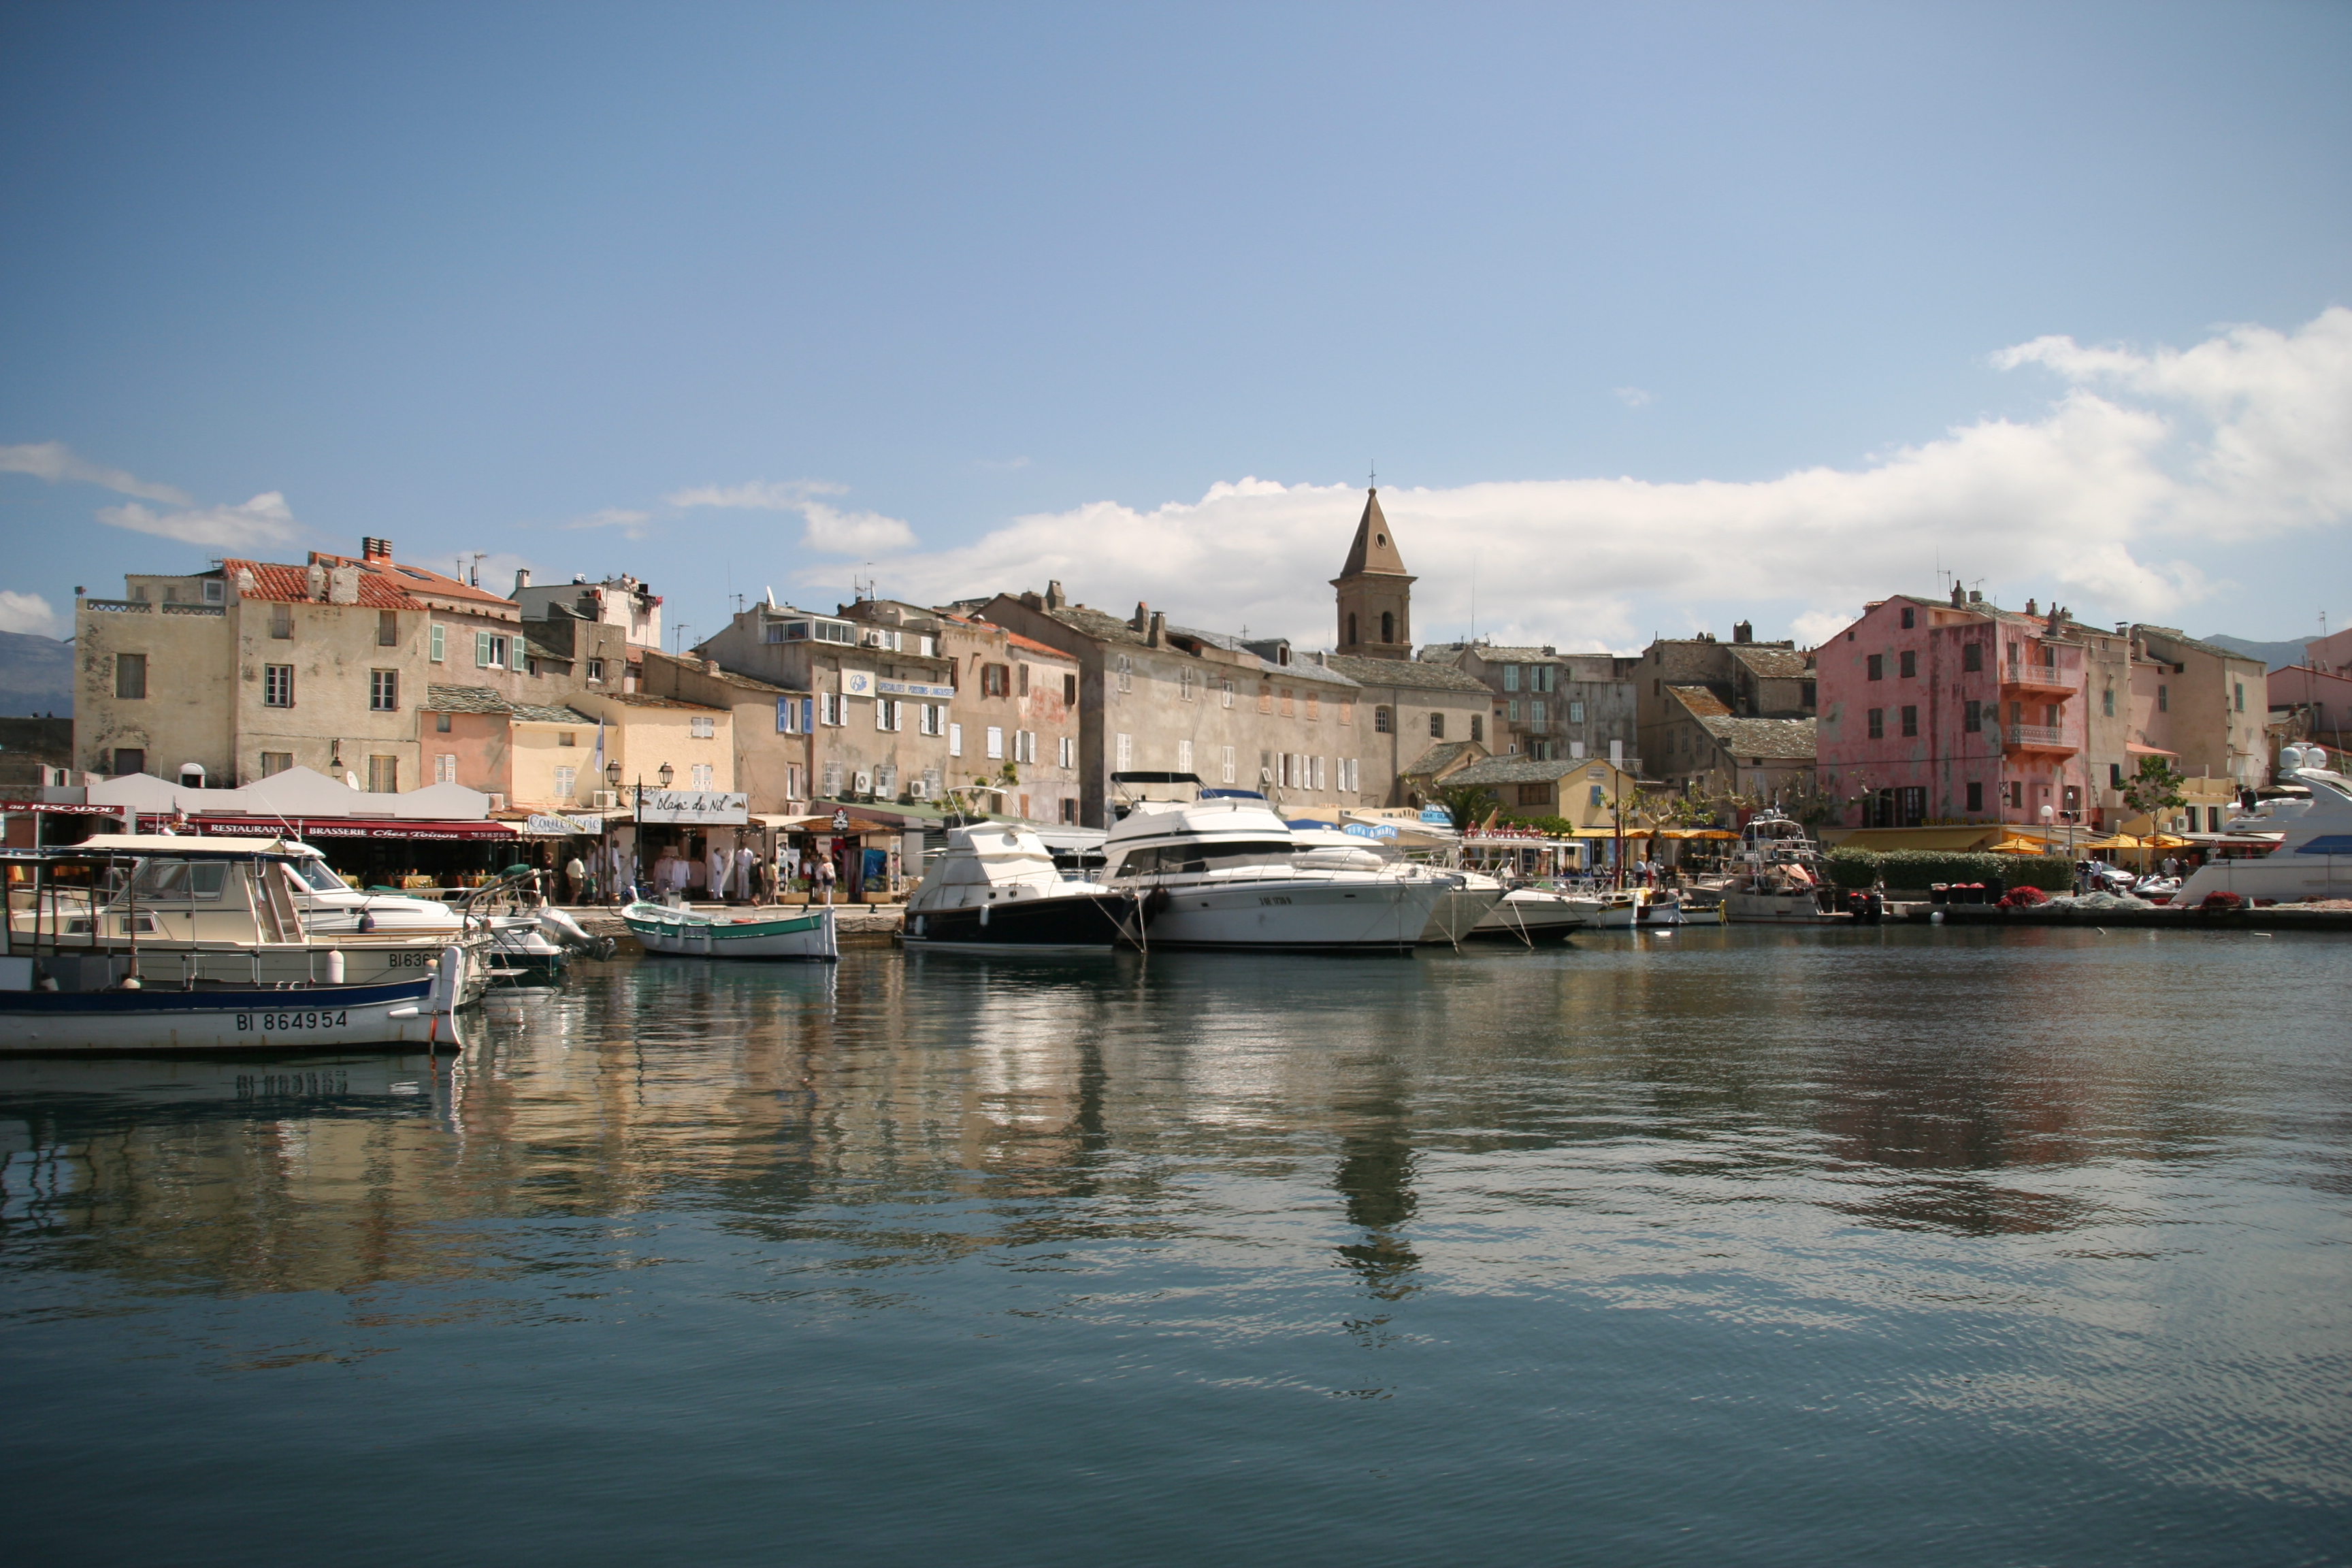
0,2,2352,651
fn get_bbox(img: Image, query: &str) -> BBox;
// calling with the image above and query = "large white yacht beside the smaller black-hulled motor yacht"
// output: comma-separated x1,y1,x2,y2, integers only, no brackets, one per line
1103,773,1458,952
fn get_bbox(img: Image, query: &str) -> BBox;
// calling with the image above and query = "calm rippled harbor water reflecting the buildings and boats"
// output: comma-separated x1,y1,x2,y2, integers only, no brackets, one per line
0,926,2352,1568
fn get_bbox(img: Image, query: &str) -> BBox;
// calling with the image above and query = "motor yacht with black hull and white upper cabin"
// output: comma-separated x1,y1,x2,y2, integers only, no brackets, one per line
901,823,1143,952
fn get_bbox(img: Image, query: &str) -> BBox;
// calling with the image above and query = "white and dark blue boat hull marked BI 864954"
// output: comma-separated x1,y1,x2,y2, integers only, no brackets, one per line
0,976,449,1056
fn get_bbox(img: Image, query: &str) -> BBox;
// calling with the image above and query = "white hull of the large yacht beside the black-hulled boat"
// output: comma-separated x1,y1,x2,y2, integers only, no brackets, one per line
1145,879,1451,952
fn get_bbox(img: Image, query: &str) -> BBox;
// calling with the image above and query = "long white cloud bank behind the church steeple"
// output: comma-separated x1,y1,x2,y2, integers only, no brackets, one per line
806,310,2352,649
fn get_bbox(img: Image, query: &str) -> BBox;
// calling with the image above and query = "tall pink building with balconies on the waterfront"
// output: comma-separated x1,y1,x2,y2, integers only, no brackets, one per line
1816,595,2100,828
